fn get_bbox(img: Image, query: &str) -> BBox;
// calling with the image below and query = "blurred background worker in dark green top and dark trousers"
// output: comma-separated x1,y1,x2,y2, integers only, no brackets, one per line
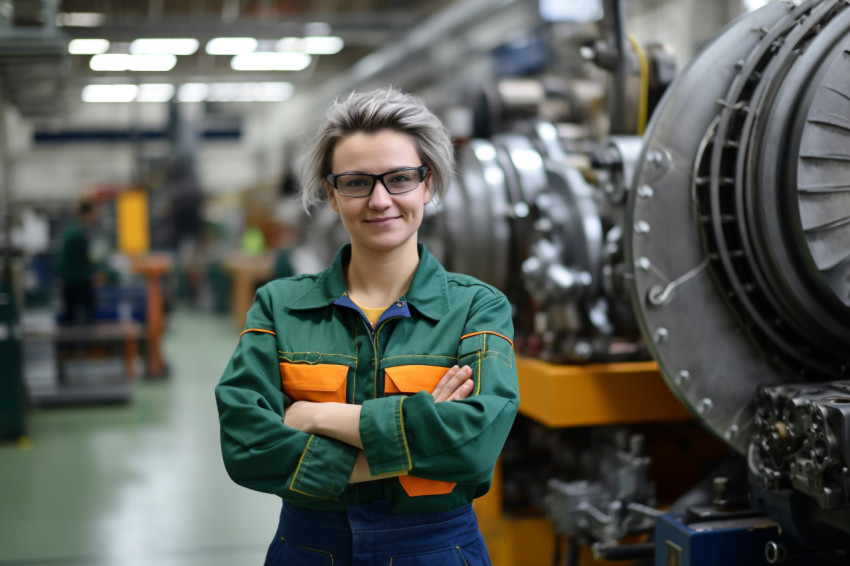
59,201,99,325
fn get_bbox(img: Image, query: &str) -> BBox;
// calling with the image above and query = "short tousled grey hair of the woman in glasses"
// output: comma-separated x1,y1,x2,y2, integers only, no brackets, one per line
301,87,455,212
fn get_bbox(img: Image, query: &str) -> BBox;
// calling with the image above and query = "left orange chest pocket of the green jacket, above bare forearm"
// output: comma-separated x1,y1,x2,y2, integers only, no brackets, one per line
280,363,348,403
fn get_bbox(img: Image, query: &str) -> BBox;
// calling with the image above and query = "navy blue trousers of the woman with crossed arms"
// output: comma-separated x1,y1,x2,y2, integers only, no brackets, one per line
265,501,490,566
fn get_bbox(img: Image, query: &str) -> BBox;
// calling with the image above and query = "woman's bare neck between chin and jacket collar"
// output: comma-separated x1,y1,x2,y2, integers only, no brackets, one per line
346,239,419,308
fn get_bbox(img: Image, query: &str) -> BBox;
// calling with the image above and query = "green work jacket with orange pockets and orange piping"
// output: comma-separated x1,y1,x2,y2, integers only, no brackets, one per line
216,245,519,513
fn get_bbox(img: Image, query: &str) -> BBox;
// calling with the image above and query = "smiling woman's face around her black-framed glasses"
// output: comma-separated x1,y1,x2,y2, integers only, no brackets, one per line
325,130,431,255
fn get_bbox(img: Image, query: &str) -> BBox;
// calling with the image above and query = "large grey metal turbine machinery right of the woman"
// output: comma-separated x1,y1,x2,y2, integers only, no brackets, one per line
430,0,850,566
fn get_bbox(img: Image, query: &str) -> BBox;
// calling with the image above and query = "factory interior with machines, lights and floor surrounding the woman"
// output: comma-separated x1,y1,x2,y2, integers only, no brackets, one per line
0,0,850,566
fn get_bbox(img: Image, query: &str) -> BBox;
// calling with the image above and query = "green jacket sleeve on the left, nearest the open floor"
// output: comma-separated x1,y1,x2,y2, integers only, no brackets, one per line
215,287,358,503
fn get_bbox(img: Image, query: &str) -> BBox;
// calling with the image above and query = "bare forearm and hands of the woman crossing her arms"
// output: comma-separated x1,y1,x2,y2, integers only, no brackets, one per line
283,366,474,483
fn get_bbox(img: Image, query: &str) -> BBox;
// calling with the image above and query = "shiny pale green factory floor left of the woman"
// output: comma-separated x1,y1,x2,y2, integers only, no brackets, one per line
0,309,280,566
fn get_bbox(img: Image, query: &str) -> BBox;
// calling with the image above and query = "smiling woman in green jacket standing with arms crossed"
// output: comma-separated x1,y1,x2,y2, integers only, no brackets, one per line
216,89,519,566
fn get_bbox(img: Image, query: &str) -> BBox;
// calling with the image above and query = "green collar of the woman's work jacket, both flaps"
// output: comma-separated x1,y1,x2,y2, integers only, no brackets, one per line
289,244,451,320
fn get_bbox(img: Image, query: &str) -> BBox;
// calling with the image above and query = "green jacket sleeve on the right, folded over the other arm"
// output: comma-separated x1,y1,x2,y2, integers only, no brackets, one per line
360,290,519,483
